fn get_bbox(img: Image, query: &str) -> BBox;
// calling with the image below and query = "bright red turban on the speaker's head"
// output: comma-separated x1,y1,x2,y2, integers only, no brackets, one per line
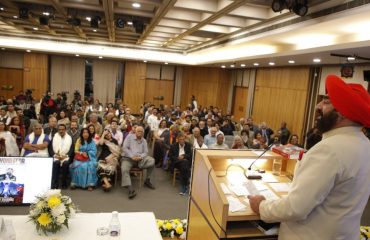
325,75,370,127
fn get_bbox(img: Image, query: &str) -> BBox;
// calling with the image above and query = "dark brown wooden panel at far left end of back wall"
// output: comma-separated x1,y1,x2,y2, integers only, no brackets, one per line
0,68,23,99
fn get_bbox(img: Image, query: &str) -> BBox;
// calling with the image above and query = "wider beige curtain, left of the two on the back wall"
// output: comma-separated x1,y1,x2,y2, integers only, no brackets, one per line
50,56,85,103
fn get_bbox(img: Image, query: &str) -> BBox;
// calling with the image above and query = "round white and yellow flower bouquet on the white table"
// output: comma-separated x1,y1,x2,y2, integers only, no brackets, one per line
29,189,76,235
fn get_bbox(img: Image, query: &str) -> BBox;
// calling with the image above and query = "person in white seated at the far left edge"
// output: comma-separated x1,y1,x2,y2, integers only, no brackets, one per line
0,121,19,157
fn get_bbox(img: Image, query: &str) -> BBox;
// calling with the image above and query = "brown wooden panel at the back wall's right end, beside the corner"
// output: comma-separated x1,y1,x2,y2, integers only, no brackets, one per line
181,67,230,111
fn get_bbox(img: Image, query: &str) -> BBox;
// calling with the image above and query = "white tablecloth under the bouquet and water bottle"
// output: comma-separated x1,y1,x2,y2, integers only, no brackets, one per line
0,212,162,240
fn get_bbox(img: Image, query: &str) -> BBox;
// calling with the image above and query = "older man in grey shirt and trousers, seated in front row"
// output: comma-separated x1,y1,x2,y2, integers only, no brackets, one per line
121,126,155,199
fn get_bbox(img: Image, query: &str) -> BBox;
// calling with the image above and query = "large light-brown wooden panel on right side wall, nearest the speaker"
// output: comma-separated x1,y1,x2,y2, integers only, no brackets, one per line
252,67,309,139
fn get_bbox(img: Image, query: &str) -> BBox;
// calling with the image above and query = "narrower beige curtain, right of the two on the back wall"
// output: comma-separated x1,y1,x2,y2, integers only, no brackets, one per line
93,60,121,103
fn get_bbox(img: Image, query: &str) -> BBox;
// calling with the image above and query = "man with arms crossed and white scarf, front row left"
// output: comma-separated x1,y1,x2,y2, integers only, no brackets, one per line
21,123,50,157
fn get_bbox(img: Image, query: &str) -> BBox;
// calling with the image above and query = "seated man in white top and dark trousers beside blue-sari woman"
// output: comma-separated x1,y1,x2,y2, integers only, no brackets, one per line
49,124,73,189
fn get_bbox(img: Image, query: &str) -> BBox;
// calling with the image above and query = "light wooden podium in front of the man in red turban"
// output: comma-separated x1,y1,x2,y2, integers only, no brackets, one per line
186,149,295,240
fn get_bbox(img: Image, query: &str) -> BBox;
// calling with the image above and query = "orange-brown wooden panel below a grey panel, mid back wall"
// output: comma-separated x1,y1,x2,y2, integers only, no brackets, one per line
144,79,175,106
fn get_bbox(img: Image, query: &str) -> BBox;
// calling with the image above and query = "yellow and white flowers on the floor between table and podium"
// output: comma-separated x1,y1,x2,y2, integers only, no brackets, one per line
157,219,188,239
